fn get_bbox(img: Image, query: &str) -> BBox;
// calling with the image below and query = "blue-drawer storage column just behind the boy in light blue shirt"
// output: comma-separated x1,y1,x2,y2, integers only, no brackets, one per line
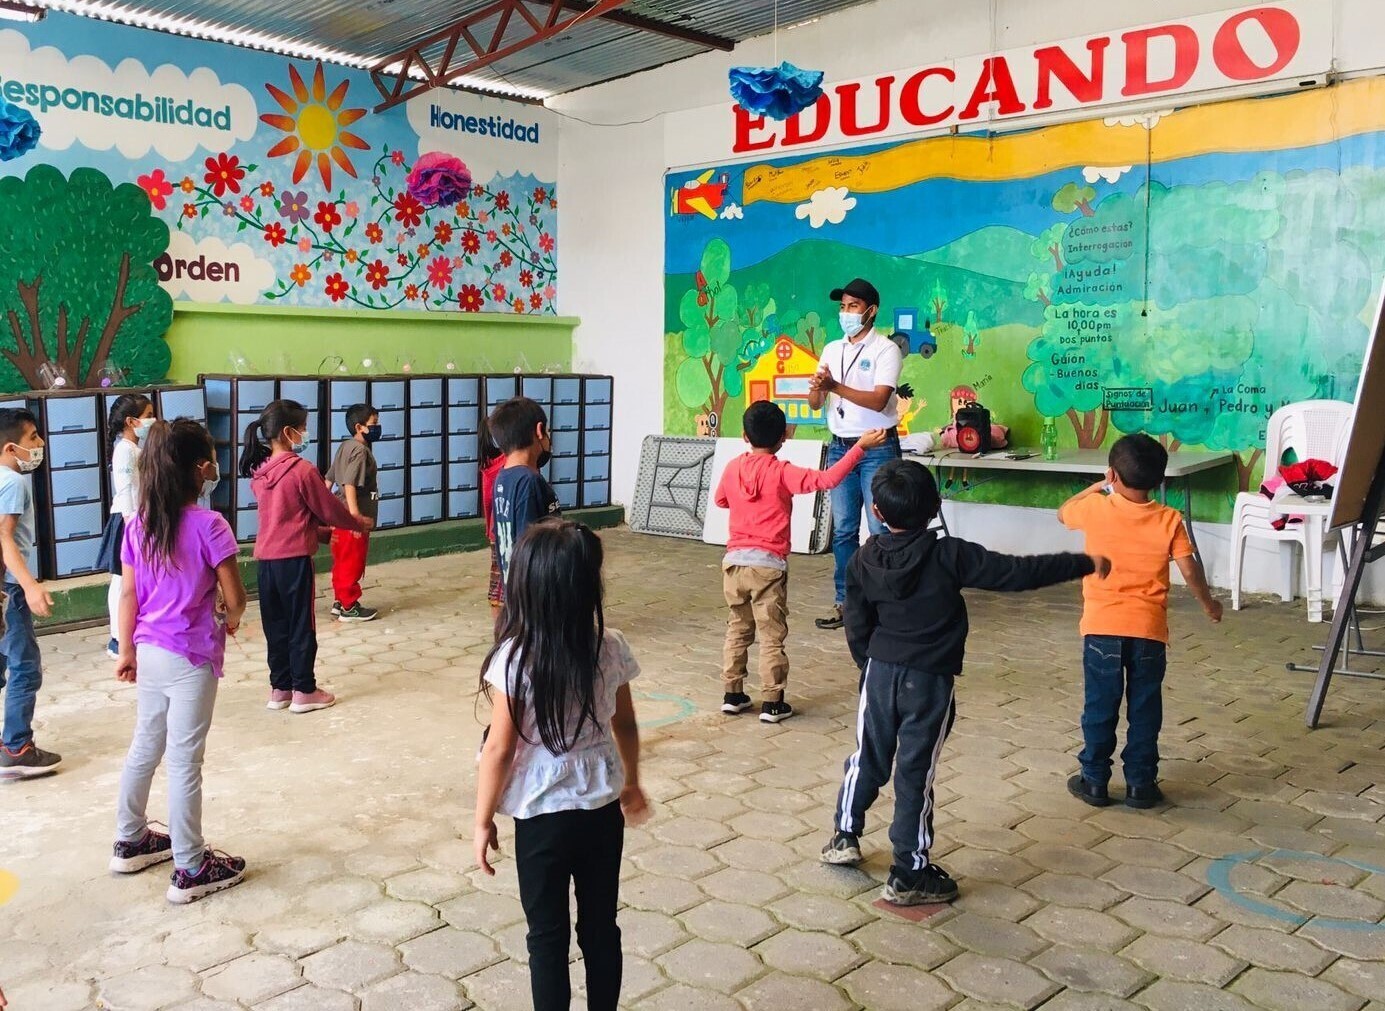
25,391,107,579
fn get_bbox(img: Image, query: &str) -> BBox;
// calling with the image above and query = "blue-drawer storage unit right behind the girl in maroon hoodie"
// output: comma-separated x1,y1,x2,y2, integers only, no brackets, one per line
199,375,328,542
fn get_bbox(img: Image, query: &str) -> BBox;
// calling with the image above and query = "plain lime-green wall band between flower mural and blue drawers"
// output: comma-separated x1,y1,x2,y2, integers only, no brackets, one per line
166,302,578,382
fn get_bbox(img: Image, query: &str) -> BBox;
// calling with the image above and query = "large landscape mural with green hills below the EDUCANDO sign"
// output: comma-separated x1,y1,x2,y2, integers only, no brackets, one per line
665,79,1385,518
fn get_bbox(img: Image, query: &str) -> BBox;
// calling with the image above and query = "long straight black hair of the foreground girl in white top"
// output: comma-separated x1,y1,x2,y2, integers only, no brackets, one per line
481,519,605,755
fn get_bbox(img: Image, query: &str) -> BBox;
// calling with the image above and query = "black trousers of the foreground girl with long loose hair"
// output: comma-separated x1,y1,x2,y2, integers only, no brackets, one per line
515,802,625,1011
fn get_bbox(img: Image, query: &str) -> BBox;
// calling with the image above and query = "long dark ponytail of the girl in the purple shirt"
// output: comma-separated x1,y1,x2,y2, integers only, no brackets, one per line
140,418,216,568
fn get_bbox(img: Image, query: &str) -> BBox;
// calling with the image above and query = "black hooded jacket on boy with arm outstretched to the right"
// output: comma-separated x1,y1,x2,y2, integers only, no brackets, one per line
842,530,1094,674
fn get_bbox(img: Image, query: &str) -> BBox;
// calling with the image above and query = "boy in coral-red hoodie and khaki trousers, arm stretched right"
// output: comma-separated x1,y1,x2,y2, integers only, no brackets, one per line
716,400,885,723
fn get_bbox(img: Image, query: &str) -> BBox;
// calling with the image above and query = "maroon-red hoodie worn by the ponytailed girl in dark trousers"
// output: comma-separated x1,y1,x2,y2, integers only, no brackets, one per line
251,453,361,561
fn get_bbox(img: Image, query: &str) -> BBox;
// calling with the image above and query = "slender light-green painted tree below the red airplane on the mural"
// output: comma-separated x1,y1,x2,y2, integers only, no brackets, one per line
674,238,745,435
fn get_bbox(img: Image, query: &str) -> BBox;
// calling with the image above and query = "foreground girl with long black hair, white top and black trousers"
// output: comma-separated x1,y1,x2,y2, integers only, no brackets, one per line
475,519,648,1011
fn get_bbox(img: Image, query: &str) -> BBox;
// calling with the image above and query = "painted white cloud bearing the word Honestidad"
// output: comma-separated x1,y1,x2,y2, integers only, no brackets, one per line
404,89,558,183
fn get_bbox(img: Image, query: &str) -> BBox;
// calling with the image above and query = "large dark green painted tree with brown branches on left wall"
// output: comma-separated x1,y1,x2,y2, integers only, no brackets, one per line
0,165,173,392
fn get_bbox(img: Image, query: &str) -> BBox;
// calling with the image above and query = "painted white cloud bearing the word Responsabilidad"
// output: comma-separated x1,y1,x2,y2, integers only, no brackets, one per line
0,30,259,162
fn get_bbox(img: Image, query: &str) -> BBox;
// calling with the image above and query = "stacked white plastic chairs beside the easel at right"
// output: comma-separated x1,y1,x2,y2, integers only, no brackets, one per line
1231,400,1352,622
